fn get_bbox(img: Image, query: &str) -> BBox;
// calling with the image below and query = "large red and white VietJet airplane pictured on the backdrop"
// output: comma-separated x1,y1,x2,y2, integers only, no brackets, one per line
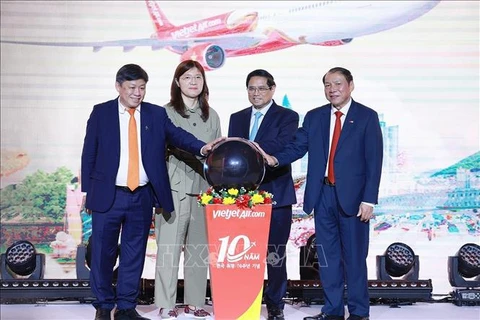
1,0,440,70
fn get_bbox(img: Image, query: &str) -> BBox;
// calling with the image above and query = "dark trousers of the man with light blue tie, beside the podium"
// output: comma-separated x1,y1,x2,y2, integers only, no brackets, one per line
264,206,292,310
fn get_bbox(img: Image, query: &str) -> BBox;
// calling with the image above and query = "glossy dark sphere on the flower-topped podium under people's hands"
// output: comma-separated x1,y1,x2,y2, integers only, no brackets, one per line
203,138,265,191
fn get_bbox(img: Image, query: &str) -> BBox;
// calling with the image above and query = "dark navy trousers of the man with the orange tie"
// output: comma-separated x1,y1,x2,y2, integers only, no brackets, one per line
90,187,153,310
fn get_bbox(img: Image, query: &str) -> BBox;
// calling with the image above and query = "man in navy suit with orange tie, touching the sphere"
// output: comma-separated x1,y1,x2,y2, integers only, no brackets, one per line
81,64,219,320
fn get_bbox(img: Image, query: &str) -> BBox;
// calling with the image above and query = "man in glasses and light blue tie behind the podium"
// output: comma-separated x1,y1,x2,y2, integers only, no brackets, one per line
228,69,298,320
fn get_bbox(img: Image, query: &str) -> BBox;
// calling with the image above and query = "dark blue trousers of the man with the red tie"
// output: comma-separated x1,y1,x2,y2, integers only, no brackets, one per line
315,185,370,316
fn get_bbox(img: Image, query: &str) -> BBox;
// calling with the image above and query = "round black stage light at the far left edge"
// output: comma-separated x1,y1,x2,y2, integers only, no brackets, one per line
0,240,45,280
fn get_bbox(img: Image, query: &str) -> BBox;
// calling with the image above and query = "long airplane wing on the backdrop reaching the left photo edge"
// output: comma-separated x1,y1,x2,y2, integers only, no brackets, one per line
0,32,267,52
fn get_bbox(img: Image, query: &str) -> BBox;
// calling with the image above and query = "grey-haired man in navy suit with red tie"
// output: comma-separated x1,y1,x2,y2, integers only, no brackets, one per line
258,67,383,320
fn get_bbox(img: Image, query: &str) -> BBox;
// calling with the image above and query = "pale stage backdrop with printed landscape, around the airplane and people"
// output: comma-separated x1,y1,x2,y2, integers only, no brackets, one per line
0,1,480,293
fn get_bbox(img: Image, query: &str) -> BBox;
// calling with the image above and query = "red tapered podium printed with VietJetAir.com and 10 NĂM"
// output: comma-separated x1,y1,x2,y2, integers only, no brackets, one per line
205,204,272,320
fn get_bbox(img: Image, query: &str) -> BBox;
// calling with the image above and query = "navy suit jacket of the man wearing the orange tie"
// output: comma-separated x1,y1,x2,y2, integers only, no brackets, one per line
81,99,205,212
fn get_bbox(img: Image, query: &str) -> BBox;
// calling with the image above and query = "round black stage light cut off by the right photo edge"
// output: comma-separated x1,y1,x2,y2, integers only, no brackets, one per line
448,243,480,306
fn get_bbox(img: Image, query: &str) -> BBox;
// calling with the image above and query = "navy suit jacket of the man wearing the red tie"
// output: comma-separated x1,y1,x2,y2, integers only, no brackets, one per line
273,100,383,216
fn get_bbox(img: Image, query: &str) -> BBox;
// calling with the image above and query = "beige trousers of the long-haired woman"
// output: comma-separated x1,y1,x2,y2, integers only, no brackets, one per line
155,192,208,309
